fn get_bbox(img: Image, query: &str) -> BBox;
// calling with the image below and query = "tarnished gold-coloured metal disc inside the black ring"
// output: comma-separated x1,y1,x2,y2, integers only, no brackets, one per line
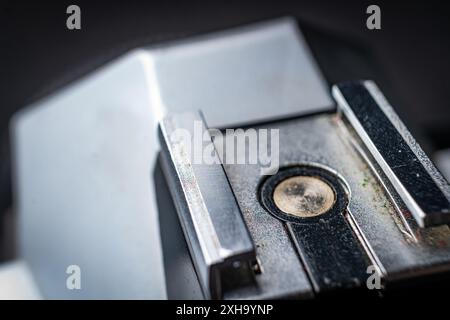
273,176,336,217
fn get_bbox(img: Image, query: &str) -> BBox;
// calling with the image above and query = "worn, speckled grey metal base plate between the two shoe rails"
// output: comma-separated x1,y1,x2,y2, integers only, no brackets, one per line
225,114,450,285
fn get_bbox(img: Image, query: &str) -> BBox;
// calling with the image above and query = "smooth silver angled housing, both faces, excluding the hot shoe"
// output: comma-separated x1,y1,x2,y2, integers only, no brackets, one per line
11,18,333,299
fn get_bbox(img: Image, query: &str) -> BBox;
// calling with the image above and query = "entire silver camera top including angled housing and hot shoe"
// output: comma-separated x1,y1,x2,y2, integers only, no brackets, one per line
11,18,450,299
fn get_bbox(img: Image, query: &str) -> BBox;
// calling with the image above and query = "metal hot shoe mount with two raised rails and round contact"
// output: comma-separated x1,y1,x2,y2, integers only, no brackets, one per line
156,20,450,299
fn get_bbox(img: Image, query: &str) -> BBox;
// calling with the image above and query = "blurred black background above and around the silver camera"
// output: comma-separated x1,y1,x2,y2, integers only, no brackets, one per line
0,0,450,222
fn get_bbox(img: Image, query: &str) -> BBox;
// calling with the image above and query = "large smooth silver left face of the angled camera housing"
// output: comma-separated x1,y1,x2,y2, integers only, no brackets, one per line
11,52,166,299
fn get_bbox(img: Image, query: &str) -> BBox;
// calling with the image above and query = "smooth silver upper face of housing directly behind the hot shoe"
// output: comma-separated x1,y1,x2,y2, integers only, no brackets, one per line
149,18,334,128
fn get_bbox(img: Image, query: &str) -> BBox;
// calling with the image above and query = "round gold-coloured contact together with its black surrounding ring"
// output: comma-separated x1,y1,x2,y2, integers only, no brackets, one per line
260,165,348,223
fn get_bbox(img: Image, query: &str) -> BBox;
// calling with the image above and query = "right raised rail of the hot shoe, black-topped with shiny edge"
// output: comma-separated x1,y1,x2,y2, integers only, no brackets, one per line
333,81,450,227
